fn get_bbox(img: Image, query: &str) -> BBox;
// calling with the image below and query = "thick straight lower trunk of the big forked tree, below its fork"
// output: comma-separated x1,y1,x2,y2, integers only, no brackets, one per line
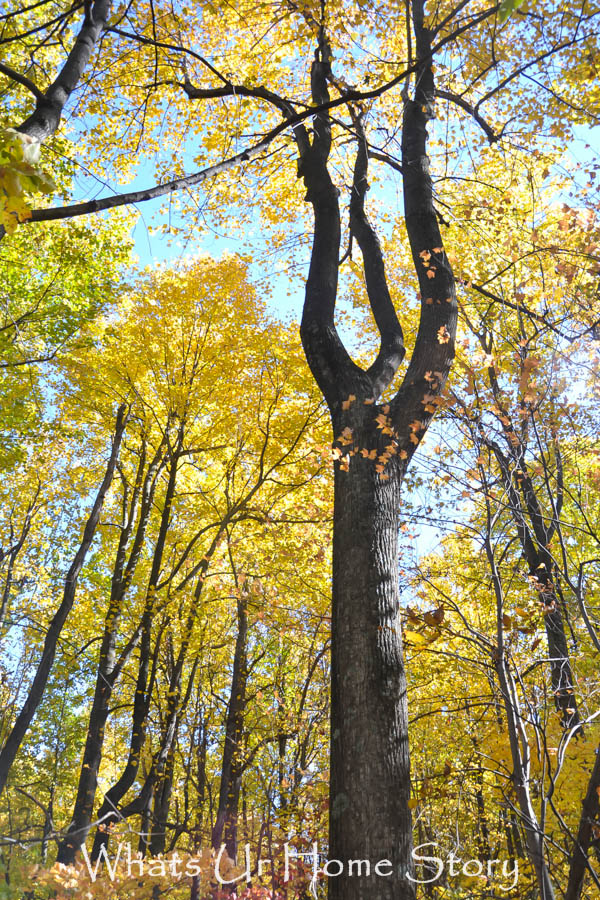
328,456,415,900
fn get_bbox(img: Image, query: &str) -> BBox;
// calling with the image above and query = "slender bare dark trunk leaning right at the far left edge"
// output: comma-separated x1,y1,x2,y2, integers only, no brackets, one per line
0,405,127,793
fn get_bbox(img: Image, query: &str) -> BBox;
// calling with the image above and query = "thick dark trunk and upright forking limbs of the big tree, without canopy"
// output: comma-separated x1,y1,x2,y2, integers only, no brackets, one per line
295,3,456,900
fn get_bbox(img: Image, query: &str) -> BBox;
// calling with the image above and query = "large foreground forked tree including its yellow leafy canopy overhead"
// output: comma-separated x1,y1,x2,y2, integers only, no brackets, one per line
1,0,597,897
